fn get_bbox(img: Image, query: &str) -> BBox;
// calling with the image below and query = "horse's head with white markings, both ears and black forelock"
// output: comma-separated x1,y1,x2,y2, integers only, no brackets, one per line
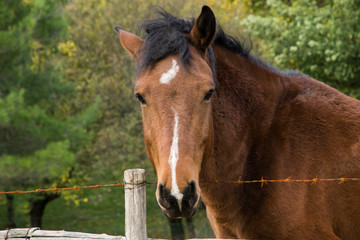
116,7,216,218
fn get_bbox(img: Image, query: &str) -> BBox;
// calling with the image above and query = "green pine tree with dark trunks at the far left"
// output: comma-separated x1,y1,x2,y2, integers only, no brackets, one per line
0,0,101,227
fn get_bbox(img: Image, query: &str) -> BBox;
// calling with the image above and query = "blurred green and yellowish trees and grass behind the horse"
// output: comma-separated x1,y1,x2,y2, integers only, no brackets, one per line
0,0,360,239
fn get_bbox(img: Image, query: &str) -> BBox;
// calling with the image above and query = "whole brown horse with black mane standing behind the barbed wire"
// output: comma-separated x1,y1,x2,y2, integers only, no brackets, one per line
115,6,360,239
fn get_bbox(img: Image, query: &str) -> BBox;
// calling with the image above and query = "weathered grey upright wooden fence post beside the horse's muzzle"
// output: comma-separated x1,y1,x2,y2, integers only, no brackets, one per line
124,169,147,240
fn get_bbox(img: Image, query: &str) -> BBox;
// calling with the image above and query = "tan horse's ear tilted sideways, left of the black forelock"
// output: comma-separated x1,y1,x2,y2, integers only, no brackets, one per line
114,26,144,62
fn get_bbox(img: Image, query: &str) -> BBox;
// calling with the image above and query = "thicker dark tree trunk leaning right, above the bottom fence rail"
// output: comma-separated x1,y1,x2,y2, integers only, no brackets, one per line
30,194,59,228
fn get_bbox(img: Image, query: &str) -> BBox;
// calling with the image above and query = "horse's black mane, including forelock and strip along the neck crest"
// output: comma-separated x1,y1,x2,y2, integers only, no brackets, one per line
138,9,301,75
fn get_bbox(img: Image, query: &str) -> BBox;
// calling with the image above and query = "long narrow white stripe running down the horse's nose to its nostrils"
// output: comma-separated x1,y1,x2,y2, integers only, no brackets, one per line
169,111,183,202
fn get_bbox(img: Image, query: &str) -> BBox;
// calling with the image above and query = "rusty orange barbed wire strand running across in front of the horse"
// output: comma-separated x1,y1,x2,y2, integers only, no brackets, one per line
0,177,360,197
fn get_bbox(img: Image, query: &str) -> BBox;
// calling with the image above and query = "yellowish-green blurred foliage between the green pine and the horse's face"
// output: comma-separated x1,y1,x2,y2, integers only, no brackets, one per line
62,0,150,183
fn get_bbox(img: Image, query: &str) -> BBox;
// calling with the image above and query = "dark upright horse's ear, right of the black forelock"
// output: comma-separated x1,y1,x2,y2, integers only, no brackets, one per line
190,6,216,53
